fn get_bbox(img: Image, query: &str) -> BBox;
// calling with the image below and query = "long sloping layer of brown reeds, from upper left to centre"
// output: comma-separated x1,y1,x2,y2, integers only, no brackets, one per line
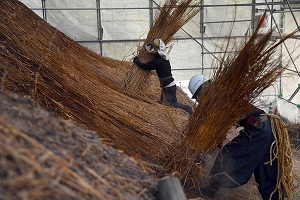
0,0,193,166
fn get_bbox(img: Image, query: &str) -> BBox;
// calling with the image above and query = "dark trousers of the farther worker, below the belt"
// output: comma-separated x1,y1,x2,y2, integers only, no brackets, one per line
161,85,193,115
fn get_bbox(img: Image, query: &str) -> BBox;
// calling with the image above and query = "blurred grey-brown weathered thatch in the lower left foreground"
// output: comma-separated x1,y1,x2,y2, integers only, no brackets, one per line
0,90,157,200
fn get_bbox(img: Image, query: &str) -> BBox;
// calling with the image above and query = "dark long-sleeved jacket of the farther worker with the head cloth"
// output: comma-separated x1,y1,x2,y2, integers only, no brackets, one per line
135,54,174,88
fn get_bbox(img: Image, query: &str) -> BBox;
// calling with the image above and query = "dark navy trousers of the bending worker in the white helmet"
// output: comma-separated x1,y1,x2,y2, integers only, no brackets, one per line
211,120,278,200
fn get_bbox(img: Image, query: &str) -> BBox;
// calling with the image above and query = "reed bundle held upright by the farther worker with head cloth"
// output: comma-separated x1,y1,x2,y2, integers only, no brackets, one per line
122,0,201,94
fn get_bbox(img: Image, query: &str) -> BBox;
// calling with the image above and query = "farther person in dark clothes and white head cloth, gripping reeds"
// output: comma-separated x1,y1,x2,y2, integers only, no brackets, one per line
133,38,193,115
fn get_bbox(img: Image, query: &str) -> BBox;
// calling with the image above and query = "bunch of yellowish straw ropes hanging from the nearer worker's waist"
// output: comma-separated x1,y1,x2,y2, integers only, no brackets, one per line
269,115,300,199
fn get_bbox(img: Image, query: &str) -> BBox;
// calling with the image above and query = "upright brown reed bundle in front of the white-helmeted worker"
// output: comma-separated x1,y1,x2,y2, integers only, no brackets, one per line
163,15,298,195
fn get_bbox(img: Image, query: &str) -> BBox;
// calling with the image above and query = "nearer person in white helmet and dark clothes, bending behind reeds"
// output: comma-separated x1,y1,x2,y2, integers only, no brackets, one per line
189,74,279,200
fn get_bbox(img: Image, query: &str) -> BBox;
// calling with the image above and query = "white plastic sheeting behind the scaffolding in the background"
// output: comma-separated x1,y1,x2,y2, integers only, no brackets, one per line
21,0,300,123
